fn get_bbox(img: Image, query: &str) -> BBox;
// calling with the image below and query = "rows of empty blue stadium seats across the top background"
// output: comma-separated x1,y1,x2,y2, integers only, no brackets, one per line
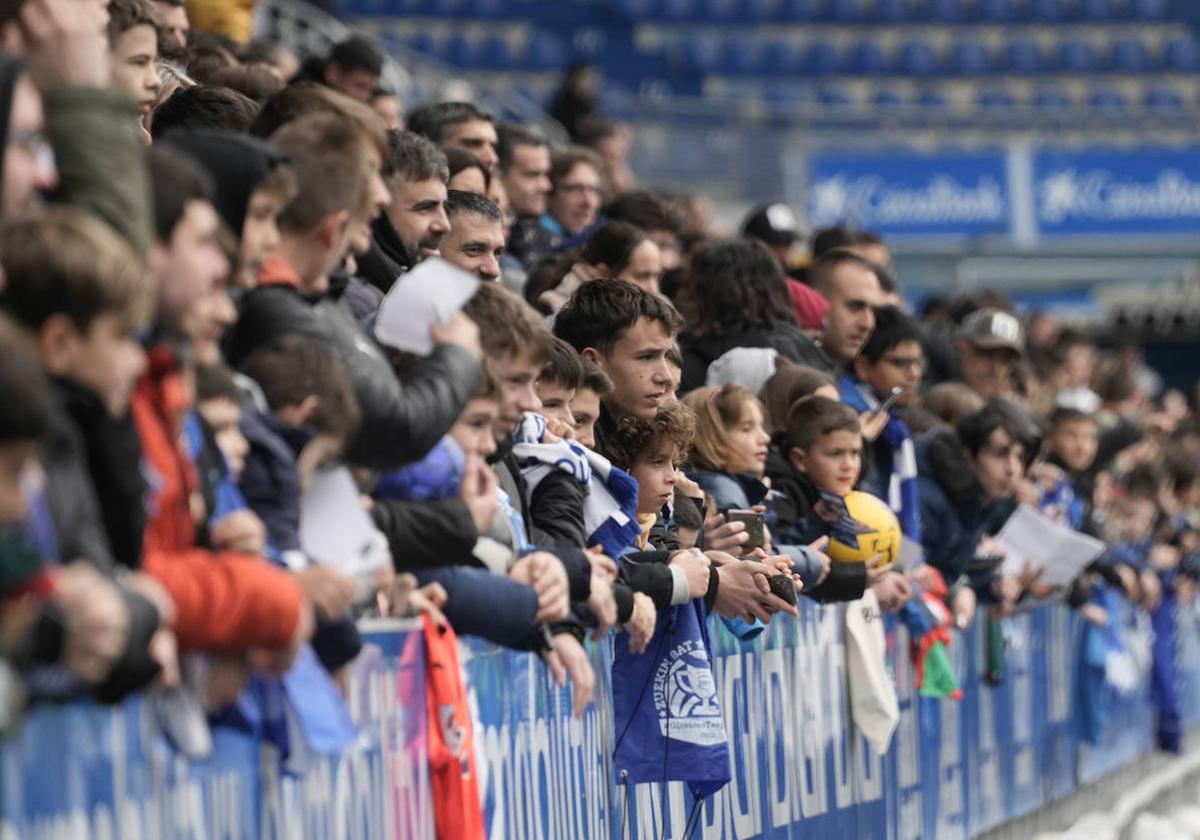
350,0,1200,127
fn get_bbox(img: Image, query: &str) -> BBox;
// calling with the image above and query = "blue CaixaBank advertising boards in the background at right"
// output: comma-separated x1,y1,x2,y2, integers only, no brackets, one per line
803,146,1200,244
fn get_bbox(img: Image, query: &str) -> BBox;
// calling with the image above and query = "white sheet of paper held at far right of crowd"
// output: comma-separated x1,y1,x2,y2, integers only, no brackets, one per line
996,504,1104,587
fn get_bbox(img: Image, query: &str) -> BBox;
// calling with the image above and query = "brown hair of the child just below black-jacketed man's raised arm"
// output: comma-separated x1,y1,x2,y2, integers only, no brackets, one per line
241,334,361,440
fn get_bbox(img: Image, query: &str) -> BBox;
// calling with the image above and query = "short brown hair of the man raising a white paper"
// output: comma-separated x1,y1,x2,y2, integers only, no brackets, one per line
271,114,367,233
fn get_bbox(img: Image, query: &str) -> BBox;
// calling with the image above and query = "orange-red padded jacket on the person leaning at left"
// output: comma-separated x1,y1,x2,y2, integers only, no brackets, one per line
132,347,304,650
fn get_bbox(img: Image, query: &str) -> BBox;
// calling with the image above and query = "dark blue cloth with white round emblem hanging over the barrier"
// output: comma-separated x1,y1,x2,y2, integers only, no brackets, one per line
612,600,730,799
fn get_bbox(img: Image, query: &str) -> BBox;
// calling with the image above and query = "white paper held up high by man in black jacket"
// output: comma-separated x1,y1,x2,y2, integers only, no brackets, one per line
374,257,479,356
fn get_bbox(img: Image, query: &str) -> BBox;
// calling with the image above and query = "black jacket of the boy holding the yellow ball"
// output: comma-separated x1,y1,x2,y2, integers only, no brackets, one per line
767,436,866,602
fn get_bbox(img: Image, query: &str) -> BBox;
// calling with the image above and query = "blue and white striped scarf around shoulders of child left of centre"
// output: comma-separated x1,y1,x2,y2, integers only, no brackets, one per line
512,413,641,557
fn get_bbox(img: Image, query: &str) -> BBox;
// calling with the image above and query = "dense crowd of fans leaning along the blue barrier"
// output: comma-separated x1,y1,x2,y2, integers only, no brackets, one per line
0,0,1200,825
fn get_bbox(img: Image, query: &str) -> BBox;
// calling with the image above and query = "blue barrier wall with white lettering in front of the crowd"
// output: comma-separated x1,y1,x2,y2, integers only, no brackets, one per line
0,605,1200,840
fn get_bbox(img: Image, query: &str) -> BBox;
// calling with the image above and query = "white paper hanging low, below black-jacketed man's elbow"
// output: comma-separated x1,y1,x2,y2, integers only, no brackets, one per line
300,467,390,578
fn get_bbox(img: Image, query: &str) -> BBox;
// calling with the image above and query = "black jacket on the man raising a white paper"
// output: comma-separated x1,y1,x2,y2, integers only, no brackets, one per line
227,278,480,469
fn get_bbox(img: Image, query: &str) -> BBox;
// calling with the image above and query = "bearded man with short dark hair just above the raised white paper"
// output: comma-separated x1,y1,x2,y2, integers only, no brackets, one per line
359,130,450,294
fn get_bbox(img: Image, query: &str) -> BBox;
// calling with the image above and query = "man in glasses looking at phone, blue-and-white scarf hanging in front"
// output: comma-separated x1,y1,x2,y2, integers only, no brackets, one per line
838,306,925,540
